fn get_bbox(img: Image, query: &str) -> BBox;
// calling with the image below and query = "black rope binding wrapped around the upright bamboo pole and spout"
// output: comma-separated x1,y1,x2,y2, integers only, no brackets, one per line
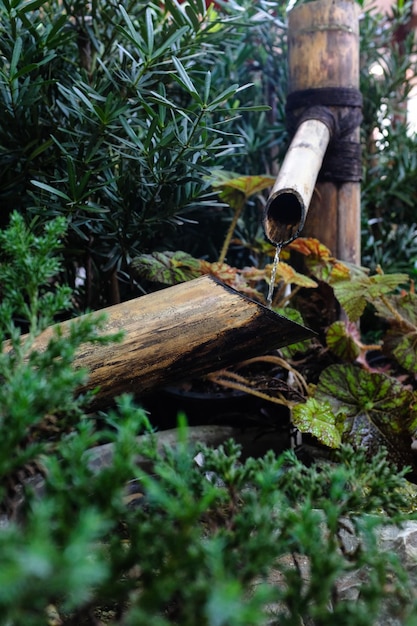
285,87,362,183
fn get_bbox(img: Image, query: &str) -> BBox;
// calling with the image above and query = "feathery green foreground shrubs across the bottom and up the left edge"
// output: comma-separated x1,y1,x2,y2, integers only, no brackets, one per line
0,214,414,626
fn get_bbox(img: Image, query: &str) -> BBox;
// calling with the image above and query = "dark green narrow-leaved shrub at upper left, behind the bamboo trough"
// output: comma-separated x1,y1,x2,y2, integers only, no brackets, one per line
0,0,274,309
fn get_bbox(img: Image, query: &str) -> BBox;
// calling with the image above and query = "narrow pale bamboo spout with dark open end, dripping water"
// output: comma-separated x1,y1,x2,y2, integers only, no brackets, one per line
264,119,330,246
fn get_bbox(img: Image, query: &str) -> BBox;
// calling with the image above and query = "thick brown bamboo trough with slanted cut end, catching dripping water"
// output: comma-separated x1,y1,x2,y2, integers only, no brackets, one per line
7,276,314,407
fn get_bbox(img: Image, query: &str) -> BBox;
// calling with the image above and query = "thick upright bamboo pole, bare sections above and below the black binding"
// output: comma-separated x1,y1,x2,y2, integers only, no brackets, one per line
288,0,361,264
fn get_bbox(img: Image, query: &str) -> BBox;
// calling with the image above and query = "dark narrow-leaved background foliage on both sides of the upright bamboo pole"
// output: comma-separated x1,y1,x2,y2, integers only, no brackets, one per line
0,0,417,310
